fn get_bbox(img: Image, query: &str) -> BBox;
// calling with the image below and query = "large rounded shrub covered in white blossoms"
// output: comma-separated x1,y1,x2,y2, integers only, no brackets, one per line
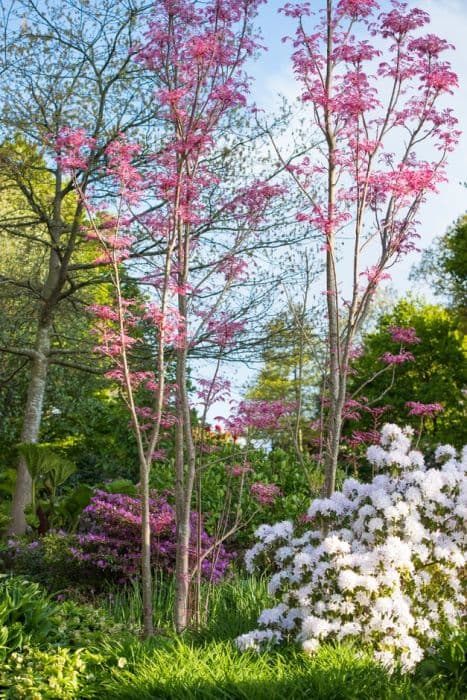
236,424,467,671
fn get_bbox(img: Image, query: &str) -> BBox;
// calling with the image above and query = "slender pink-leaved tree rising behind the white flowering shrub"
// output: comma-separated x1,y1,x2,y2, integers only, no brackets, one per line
277,0,458,495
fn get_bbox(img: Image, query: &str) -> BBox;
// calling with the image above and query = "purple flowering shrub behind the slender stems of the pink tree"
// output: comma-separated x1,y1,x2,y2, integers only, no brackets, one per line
70,490,233,583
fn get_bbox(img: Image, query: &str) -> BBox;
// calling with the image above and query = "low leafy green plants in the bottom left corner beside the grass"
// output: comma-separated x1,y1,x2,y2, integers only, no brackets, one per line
0,577,135,700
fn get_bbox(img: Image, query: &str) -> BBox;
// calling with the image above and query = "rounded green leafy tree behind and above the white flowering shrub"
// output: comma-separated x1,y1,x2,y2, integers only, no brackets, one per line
347,297,467,447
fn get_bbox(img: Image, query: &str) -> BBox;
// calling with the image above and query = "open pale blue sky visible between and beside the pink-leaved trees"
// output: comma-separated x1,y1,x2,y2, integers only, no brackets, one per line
202,0,467,420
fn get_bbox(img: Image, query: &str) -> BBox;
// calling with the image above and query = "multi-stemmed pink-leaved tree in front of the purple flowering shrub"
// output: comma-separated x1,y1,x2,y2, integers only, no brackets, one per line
57,0,282,636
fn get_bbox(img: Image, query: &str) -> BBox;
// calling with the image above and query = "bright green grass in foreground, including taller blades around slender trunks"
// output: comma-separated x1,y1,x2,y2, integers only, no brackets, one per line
93,578,465,700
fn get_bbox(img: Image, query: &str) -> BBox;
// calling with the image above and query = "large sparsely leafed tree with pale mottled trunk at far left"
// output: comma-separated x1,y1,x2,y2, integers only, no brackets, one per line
0,0,163,533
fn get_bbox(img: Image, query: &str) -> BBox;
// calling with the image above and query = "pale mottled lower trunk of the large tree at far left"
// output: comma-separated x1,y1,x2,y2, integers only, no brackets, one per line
10,324,51,535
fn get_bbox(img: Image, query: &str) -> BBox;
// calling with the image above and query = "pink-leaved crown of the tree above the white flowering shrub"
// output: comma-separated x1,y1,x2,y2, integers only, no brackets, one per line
283,0,460,294
